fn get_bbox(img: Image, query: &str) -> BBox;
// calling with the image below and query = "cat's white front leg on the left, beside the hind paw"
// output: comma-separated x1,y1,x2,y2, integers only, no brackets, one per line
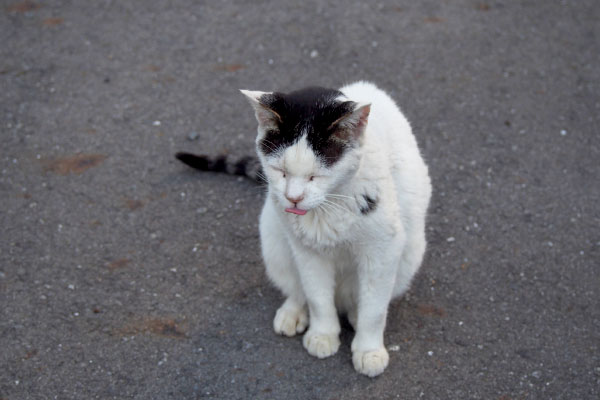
294,248,340,358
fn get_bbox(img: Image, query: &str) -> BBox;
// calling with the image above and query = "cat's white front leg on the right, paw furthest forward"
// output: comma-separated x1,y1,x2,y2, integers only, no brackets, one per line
351,243,401,377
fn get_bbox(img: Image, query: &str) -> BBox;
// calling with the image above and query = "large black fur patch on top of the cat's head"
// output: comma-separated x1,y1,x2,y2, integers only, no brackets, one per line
259,87,356,166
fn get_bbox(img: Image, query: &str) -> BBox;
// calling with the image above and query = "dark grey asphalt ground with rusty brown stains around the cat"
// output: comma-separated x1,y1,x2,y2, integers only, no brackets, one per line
0,0,600,400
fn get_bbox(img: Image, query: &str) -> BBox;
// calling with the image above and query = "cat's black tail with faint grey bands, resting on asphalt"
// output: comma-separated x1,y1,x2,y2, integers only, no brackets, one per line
175,152,265,183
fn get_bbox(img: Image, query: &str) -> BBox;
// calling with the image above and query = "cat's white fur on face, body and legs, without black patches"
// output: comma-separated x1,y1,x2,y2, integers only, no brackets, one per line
247,82,431,377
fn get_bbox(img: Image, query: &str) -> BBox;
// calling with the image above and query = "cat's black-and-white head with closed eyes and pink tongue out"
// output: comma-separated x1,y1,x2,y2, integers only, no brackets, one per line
242,87,370,215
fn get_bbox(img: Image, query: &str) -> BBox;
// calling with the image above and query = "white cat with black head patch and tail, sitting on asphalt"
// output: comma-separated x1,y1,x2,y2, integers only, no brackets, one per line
177,81,432,377
